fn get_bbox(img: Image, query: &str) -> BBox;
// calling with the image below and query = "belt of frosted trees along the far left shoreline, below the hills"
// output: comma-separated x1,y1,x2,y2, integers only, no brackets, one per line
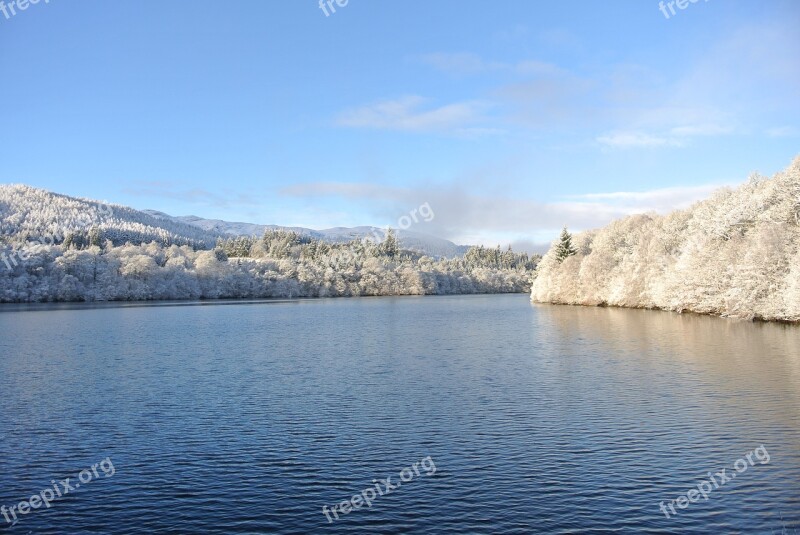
0,224,531,302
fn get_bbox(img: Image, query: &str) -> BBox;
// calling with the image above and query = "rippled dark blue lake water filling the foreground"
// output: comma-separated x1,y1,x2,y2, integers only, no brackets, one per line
0,295,800,534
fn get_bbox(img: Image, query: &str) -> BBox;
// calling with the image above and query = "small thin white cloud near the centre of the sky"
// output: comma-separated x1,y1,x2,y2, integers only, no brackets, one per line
336,96,491,134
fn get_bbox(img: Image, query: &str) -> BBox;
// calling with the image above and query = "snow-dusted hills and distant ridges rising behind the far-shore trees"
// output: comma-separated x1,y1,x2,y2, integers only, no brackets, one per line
0,184,468,257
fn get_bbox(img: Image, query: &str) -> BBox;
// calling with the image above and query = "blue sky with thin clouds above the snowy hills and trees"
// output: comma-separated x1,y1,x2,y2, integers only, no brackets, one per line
0,0,800,246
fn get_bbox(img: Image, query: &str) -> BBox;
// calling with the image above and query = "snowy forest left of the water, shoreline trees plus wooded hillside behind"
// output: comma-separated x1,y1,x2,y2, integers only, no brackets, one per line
0,186,539,302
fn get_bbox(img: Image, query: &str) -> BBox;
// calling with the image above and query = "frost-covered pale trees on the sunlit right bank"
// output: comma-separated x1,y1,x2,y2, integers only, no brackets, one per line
531,158,800,322
